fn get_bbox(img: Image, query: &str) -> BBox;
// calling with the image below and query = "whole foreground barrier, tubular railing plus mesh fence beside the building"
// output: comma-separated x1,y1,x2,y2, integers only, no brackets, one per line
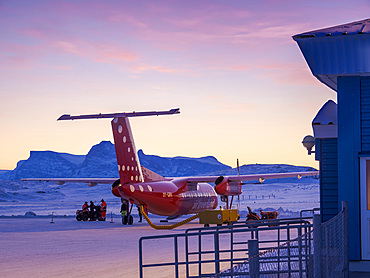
139,203,349,278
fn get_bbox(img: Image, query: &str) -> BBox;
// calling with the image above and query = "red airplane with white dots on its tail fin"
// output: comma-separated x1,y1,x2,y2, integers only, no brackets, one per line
24,109,318,224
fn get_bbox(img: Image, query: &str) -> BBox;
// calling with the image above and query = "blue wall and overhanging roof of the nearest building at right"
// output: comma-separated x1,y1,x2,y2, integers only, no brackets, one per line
293,19,370,261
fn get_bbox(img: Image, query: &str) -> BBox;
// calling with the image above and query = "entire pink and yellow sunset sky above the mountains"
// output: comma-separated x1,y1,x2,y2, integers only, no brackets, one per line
0,0,370,170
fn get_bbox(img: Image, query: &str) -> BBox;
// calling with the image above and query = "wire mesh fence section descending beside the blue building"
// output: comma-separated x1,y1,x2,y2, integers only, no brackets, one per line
216,202,349,278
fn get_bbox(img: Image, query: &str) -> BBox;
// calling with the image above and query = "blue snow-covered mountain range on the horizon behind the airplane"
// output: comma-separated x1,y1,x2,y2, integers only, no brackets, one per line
0,141,314,180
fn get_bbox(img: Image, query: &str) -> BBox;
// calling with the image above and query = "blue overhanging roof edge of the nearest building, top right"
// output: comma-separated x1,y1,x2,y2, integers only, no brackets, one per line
293,19,370,91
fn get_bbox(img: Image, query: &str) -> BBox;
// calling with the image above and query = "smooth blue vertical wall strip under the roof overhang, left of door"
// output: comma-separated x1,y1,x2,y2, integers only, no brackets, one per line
337,76,361,260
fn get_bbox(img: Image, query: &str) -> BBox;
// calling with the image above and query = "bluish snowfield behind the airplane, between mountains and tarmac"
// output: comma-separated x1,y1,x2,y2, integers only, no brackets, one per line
0,178,320,217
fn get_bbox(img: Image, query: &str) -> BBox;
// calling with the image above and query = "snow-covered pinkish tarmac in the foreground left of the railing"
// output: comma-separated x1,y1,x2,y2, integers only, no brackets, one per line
0,217,201,278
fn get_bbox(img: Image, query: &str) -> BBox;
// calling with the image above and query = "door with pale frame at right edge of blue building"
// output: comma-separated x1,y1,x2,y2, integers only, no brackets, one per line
360,157,370,260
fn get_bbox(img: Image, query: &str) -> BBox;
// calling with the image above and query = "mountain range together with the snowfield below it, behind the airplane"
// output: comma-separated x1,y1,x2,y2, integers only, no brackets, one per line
0,141,319,216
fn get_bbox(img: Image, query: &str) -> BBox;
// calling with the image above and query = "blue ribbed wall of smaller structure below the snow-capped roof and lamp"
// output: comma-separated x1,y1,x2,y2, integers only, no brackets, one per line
315,138,339,222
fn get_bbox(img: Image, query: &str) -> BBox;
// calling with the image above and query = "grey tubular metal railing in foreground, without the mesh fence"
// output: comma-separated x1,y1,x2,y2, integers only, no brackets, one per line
139,218,312,277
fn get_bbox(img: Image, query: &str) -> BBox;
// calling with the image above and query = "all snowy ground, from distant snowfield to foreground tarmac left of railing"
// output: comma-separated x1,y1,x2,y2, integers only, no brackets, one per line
0,178,319,277
